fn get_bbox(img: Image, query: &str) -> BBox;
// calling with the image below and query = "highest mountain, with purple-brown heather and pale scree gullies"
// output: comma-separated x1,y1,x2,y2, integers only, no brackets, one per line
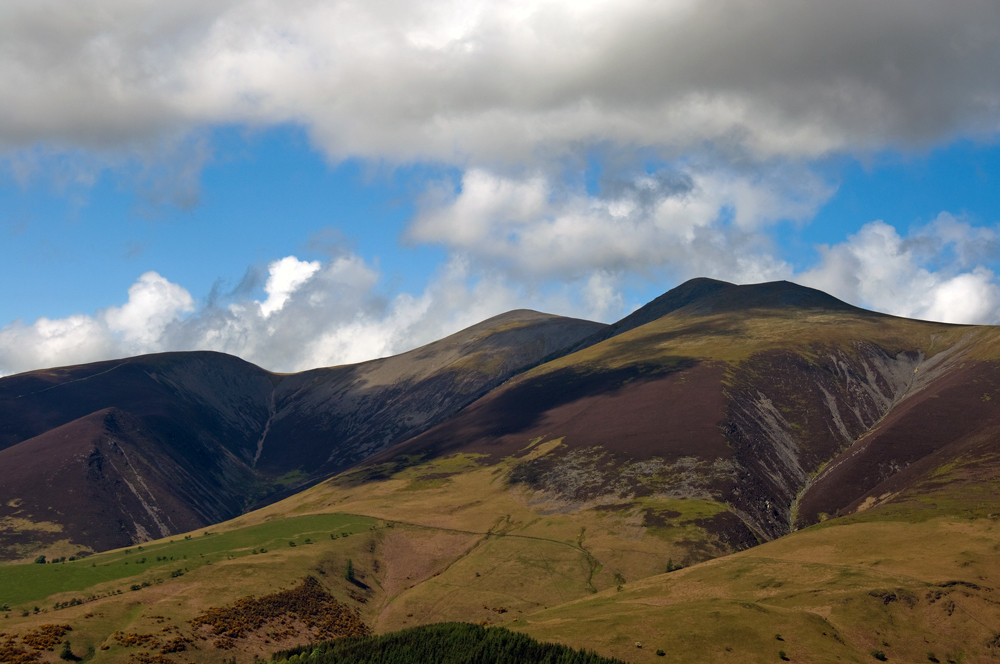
370,280,1000,548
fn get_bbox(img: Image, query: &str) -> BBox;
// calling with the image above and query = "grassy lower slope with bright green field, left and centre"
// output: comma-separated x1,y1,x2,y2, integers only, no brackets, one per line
0,440,744,661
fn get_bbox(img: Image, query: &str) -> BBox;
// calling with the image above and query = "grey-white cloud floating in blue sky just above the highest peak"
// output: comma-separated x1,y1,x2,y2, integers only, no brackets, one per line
408,169,831,281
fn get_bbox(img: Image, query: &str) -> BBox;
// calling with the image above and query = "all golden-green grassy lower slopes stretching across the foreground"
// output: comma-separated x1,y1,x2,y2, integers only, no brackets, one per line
0,441,1000,662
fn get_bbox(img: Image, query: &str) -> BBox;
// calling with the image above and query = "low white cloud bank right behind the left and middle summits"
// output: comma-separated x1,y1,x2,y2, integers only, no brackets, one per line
0,253,536,375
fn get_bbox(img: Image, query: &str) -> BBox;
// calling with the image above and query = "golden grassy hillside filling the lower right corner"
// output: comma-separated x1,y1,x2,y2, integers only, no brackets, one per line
517,454,1000,663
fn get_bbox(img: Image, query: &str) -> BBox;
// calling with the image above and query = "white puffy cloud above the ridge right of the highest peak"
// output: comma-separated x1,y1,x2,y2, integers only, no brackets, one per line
798,214,1000,324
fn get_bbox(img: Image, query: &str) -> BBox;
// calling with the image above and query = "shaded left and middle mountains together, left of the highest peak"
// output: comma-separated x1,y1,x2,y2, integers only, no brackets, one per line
0,311,604,559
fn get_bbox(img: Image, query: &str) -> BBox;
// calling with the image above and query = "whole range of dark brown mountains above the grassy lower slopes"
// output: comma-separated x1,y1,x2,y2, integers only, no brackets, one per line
0,279,997,557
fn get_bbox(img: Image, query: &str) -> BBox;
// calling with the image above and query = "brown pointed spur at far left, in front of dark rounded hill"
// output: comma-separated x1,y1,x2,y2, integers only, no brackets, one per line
0,408,246,558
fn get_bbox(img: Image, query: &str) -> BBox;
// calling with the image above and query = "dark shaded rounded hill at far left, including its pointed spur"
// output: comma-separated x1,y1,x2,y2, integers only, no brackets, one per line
0,353,275,553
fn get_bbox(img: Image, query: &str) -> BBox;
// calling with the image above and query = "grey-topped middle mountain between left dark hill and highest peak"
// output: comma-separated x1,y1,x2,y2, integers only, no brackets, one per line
258,310,605,475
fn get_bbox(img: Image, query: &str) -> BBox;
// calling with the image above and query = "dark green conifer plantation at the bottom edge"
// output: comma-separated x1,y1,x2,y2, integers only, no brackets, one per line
272,623,624,664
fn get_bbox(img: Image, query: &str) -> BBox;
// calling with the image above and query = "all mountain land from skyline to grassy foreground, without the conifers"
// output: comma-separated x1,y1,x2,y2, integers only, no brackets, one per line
0,280,1000,663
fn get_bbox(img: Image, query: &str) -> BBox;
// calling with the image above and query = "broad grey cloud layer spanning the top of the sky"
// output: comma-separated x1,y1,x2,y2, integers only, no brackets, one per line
0,0,1000,163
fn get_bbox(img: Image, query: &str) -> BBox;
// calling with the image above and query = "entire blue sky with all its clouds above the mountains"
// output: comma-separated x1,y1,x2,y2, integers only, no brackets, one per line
0,0,1000,375
